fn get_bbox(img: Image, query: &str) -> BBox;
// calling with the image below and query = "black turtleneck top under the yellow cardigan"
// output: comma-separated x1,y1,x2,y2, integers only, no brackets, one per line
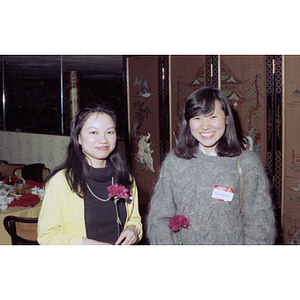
84,167,127,244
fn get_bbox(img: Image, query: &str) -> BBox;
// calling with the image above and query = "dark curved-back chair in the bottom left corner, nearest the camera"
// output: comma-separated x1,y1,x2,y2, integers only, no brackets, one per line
3,216,39,245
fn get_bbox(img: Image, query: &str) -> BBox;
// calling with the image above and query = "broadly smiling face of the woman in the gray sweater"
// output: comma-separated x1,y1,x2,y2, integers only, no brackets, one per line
189,100,228,154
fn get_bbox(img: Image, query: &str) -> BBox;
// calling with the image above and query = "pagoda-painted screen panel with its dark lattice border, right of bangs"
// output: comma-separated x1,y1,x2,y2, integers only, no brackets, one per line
220,55,282,243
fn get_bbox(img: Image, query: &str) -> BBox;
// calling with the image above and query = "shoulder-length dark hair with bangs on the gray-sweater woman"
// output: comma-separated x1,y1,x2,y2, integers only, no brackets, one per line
174,87,242,159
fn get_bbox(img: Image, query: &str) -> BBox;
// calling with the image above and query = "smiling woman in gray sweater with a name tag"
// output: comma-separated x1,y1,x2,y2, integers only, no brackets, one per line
147,88,275,245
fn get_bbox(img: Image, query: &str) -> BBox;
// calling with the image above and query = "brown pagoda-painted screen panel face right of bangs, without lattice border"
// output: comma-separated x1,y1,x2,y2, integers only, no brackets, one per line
221,55,267,165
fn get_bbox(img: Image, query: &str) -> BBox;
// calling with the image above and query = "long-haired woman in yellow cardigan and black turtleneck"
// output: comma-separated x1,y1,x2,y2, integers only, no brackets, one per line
38,104,142,245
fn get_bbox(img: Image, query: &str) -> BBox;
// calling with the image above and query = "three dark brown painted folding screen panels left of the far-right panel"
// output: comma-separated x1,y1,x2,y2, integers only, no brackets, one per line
126,55,284,244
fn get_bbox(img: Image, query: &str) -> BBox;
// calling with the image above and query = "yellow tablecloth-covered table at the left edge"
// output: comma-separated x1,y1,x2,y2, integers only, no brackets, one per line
0,201,42,245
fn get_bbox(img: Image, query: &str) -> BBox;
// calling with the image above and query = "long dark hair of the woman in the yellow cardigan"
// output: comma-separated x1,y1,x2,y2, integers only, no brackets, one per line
46,104,133,197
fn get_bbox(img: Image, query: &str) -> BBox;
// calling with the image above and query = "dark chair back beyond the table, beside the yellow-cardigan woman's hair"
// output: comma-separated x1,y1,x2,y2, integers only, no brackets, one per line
13,164,50,182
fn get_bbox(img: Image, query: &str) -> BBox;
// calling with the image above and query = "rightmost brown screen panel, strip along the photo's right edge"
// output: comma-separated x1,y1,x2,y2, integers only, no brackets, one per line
282,55,300,244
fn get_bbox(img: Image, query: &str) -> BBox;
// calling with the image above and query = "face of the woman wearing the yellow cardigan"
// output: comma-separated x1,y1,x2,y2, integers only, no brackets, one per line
78,113,117,168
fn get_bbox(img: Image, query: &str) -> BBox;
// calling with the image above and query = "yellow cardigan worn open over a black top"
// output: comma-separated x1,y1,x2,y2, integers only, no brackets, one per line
38,170,143,245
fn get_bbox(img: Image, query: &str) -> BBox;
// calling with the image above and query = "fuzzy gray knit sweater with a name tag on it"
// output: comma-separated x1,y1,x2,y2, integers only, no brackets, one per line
147,151,275,245
